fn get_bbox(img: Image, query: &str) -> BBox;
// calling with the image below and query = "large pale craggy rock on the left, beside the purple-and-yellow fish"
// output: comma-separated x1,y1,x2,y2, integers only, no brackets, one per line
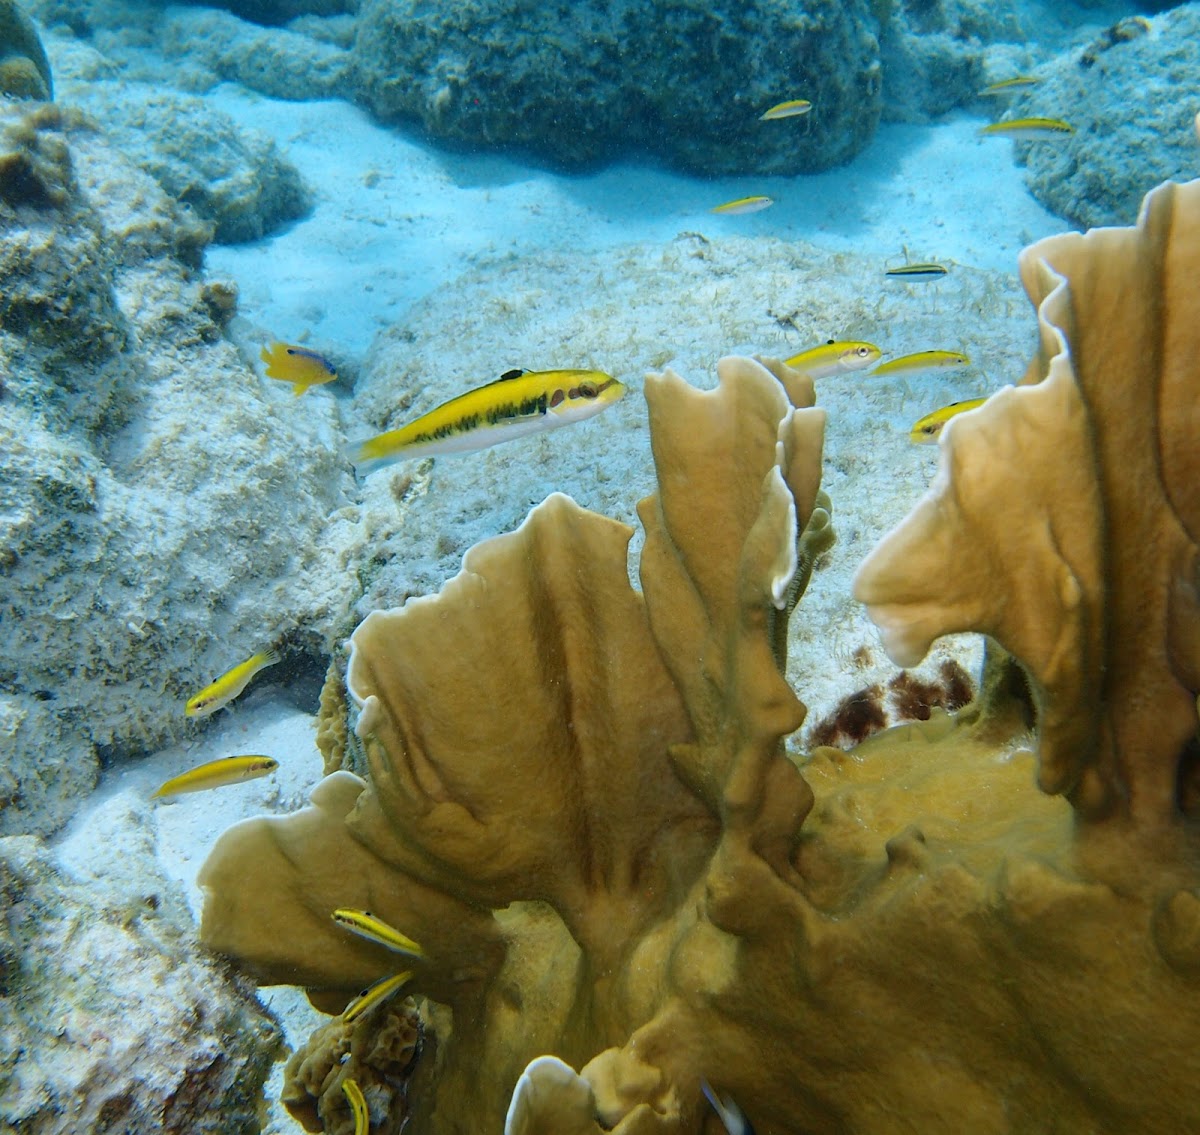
0,107,358,834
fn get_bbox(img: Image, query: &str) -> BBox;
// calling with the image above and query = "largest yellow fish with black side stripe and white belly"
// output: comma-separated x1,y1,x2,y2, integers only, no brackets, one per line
349,371,625,475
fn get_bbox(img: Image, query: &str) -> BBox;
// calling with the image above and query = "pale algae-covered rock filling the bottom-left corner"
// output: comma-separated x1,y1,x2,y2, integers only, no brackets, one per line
0,820,280,1135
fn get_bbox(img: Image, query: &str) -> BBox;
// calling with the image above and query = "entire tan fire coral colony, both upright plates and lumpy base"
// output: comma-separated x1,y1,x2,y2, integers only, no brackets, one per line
202,184,1200,1135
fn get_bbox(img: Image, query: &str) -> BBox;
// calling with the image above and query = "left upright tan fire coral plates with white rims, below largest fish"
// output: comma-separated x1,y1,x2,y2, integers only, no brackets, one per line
200,359,828,1133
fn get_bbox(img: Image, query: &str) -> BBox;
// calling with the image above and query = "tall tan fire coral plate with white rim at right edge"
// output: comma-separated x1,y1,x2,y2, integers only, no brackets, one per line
856,181,1200,854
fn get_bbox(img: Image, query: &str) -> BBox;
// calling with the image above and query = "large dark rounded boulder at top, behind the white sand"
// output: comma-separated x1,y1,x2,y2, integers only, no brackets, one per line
355,0,881,175
